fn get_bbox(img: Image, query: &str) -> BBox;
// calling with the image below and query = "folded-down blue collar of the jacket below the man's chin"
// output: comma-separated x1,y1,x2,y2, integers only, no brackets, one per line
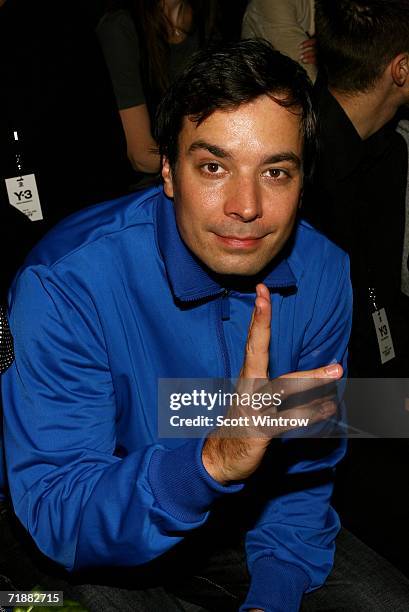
156,189,296,302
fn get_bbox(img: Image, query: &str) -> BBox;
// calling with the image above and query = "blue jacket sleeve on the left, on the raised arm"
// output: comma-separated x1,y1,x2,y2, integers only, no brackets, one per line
2,266,241,570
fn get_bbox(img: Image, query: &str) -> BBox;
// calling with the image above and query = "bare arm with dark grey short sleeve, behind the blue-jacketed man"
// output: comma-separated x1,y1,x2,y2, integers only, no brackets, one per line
97,11,160,173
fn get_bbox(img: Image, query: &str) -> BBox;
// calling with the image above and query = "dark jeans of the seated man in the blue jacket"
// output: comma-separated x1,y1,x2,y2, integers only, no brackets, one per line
0,502,409,612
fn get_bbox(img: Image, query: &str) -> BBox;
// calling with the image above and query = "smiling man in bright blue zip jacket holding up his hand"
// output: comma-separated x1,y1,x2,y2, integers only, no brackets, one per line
3,41,409,612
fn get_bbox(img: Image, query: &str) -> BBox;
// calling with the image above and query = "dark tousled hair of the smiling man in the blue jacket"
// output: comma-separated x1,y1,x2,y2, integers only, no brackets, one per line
154,39,317,179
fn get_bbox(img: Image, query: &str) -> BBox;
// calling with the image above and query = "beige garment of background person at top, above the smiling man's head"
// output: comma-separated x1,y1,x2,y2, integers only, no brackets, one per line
242,0,317,81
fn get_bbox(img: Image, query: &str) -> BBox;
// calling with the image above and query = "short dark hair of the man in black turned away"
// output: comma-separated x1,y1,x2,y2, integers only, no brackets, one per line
315,0,409,92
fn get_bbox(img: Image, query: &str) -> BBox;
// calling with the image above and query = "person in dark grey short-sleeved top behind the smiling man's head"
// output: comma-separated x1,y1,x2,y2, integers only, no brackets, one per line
97,0,219,186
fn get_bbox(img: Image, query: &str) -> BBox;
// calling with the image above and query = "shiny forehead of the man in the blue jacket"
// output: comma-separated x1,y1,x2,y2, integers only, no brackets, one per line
179,95,302,155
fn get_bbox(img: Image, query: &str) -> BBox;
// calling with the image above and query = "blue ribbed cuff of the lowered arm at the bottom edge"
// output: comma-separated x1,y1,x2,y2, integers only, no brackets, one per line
240,557,310,612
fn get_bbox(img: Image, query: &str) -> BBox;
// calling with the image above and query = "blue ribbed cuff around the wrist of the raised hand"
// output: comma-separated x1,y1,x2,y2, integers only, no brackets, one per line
148,439,244,523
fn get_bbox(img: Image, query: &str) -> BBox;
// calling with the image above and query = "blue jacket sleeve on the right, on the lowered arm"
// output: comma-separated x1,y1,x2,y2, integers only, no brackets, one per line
242,255,352,612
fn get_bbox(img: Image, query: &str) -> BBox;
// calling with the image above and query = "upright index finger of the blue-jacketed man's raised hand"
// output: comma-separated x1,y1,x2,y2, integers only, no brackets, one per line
241,284,271,378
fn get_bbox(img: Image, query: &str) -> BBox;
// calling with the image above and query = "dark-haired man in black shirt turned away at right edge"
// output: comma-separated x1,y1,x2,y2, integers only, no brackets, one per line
304,0,409,572
